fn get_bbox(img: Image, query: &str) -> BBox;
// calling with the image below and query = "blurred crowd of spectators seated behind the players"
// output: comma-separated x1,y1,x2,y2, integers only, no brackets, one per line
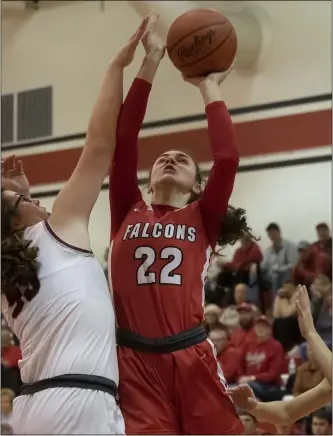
1,223,332,435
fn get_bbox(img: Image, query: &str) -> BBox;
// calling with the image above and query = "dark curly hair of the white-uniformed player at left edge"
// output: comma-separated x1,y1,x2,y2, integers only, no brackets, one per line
1,189,40,318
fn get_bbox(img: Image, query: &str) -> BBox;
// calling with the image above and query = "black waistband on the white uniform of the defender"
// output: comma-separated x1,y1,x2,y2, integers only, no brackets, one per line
20,374,118,399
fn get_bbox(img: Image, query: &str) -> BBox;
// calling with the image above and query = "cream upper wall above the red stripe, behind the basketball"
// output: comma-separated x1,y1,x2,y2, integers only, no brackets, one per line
2,1,331,144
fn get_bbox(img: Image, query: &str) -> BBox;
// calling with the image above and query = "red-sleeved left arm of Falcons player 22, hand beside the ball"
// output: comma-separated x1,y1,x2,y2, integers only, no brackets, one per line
109,15,165,238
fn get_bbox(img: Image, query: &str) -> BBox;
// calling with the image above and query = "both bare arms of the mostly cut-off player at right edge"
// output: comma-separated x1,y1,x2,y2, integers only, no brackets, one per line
228,286,332,426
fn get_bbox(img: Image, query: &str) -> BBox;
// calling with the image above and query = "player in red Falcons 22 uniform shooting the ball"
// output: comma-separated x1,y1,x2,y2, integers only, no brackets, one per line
109,16,250,434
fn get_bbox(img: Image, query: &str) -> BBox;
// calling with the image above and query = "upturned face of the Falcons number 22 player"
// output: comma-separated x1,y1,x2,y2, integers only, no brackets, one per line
150,150,201,194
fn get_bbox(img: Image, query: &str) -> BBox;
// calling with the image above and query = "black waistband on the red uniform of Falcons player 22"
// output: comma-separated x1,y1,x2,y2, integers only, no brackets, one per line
117,325,207,353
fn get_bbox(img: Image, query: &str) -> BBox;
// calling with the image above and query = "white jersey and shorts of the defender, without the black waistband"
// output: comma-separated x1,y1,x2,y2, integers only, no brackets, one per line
2,222,121,434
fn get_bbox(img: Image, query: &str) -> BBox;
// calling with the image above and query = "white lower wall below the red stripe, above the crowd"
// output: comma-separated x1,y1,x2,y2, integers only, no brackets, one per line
41,158,332,260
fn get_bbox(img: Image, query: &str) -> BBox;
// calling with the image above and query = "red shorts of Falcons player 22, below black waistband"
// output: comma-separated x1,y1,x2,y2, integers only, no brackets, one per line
118,341,244,435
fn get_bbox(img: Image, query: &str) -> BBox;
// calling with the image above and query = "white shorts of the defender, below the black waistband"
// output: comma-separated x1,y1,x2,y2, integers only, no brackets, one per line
12,388,125,435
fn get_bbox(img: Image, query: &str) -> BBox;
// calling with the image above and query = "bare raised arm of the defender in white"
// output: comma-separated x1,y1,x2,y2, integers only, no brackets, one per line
49,20,147,252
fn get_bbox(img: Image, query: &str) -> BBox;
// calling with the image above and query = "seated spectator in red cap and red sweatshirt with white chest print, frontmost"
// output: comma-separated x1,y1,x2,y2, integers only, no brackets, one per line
239,315,284,401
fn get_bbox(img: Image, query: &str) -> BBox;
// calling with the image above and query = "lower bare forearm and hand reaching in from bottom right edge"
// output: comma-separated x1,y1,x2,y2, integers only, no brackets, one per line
229,379,332,425
